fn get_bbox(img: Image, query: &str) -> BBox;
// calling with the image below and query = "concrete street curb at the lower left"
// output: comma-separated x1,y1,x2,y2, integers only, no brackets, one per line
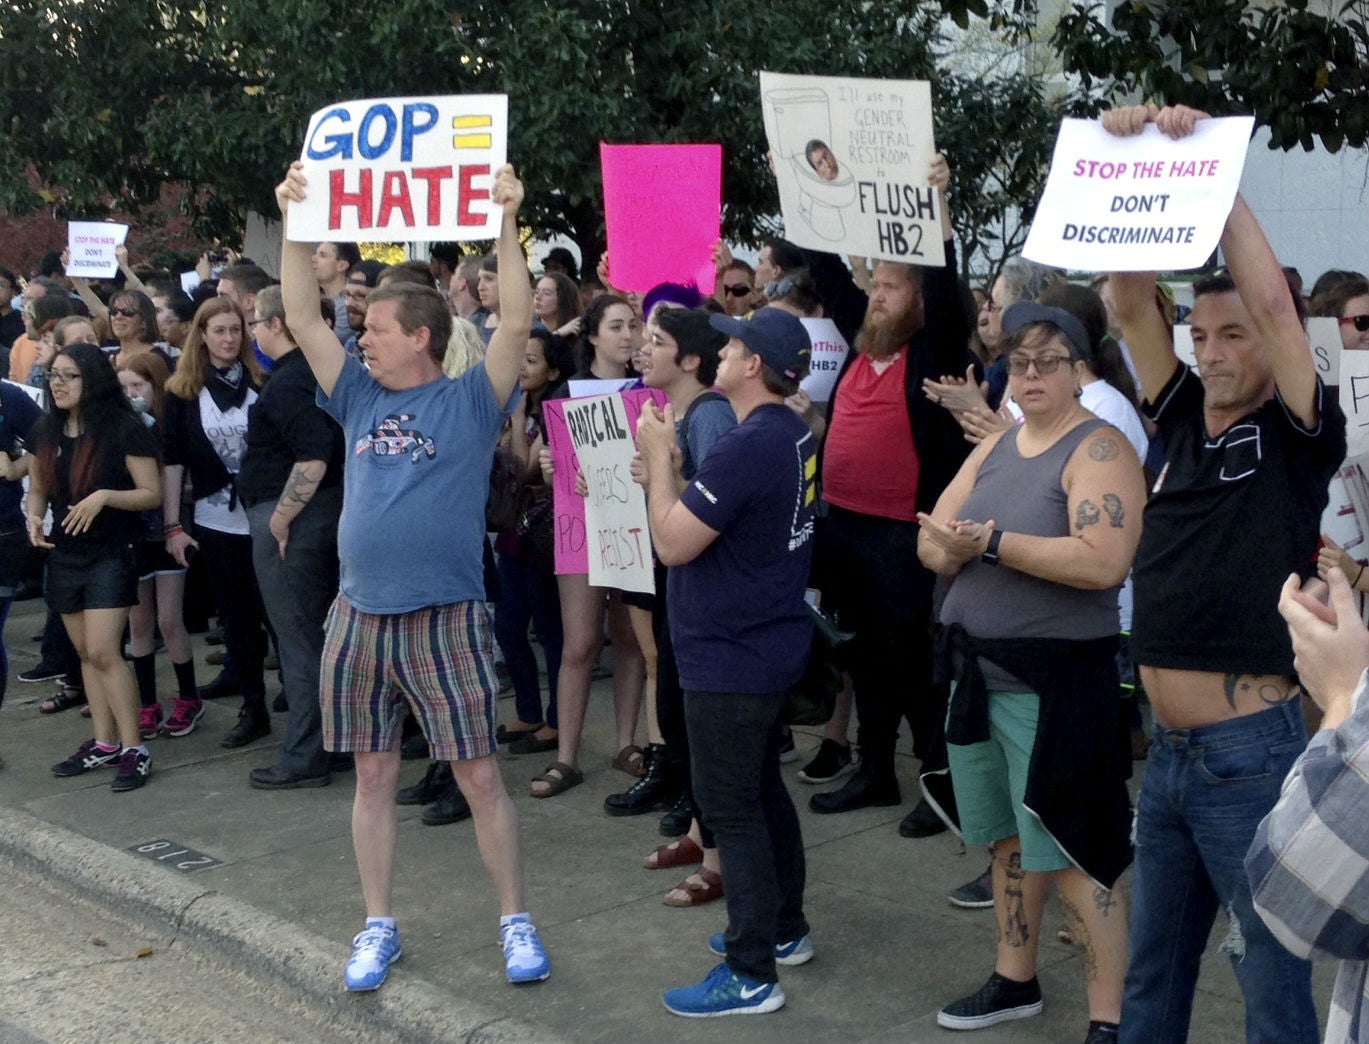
0,809,560,1044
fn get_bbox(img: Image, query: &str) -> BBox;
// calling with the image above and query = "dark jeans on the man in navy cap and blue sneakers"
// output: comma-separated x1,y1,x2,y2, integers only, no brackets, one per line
685,690,808,982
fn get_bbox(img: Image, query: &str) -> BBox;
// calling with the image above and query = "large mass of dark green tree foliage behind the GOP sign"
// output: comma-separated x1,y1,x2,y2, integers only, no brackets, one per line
0,0,1053,277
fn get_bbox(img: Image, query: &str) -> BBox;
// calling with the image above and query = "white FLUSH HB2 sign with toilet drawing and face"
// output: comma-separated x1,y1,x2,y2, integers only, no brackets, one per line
761,73,945,265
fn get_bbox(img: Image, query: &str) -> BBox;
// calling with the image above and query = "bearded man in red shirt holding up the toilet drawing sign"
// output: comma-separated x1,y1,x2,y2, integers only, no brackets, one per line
809,155,969,835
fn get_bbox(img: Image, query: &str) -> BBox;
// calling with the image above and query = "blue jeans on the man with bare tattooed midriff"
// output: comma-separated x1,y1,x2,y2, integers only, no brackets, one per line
1121,699,1320,1044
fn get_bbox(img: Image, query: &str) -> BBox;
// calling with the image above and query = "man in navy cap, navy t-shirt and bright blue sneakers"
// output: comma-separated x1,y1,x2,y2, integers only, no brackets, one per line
637,308,817,1015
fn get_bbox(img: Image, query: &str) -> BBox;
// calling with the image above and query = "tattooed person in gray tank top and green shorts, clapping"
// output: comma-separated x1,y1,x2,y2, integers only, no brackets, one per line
919,302,1144,1044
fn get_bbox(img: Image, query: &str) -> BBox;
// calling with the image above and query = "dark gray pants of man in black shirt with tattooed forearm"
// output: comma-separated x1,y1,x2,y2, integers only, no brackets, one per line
248,487,342,776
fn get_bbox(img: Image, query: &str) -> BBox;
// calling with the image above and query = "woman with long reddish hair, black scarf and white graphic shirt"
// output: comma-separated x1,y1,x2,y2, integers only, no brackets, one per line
162,297,271,748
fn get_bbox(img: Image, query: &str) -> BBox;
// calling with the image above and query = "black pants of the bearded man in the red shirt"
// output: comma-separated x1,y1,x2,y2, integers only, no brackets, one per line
817,508,949,783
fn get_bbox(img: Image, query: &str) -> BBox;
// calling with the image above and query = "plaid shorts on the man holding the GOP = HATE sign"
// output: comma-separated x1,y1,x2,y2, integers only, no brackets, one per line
319,595,500,761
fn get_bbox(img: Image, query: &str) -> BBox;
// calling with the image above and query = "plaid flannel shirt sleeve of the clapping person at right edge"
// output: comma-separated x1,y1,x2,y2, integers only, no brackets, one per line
1246,670,1369,1044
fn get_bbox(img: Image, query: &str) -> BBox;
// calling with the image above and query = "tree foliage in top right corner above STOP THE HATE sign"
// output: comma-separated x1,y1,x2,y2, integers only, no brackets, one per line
1051,0,1369,152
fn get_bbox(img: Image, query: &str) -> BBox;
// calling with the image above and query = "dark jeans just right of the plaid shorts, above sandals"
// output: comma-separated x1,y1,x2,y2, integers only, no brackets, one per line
494,554,563,729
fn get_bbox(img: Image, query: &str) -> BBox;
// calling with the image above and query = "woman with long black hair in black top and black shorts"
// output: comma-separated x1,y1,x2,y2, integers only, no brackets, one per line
27,345,162,791
